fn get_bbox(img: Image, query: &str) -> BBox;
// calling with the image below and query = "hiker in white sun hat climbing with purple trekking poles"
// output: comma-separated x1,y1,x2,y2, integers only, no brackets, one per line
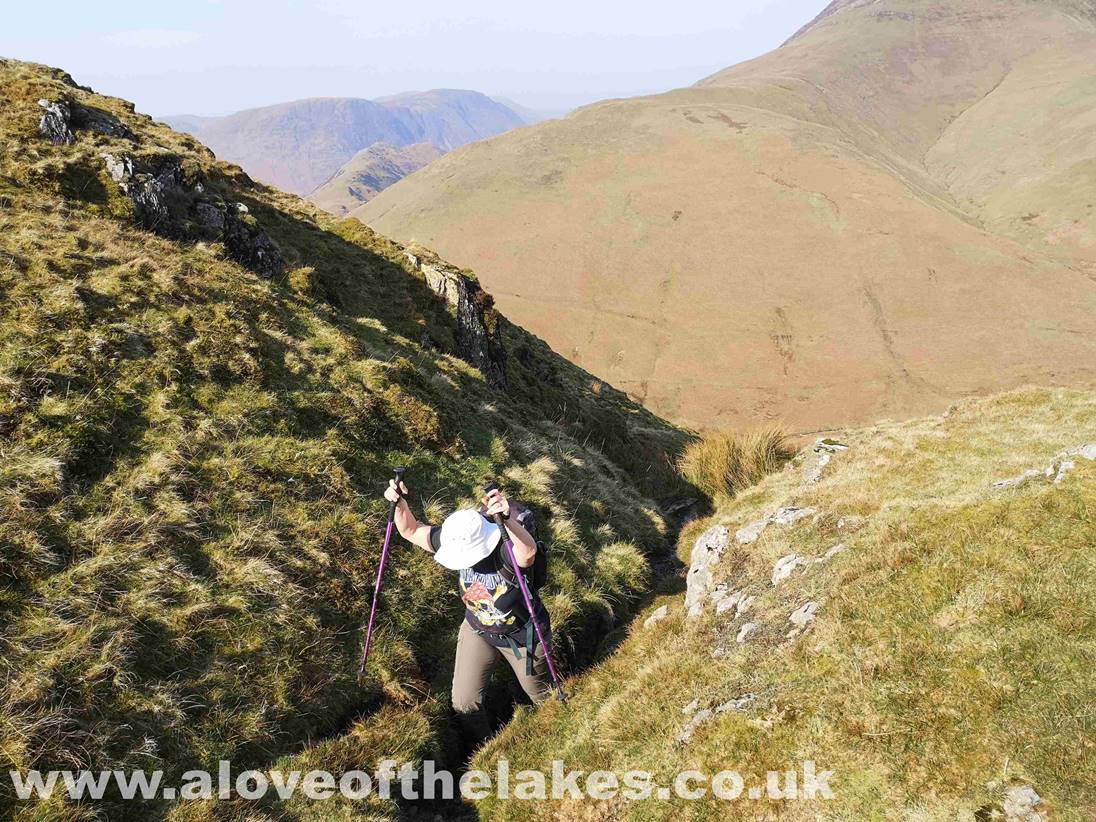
385,480,551,744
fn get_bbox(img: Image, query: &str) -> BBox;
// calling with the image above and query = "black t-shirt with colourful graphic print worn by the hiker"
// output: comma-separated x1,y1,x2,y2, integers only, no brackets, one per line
460,541,548,647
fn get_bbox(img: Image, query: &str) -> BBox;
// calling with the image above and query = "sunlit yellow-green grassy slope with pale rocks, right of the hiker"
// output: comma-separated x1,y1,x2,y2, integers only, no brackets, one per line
480,390,1096,820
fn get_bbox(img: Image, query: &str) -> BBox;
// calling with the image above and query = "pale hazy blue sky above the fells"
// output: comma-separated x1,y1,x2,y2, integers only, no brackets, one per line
0,0,827,115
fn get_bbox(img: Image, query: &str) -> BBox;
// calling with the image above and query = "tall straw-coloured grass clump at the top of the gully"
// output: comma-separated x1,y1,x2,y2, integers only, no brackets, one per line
677,429,795,499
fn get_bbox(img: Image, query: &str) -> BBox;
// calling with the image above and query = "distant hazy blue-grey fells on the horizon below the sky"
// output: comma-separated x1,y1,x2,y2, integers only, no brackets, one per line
175,89,525,196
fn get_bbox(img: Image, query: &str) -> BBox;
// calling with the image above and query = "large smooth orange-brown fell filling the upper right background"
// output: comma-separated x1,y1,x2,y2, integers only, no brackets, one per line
354,0,1096,429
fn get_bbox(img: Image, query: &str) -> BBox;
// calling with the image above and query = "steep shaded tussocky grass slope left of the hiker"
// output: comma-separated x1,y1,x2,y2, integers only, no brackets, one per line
0,61,683,819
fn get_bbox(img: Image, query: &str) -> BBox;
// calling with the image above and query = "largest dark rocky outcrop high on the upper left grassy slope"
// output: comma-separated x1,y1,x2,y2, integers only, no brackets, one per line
102,153,285,278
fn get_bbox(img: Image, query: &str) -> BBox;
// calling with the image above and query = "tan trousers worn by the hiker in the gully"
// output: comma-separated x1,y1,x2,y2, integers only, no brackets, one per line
453,620,551,735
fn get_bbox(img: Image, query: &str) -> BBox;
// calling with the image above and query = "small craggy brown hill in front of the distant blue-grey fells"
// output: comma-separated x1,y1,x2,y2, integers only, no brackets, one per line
308,142,444,217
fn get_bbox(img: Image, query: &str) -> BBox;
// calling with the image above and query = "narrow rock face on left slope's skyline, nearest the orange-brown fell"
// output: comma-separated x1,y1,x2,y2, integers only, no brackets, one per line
404,249,506,389
